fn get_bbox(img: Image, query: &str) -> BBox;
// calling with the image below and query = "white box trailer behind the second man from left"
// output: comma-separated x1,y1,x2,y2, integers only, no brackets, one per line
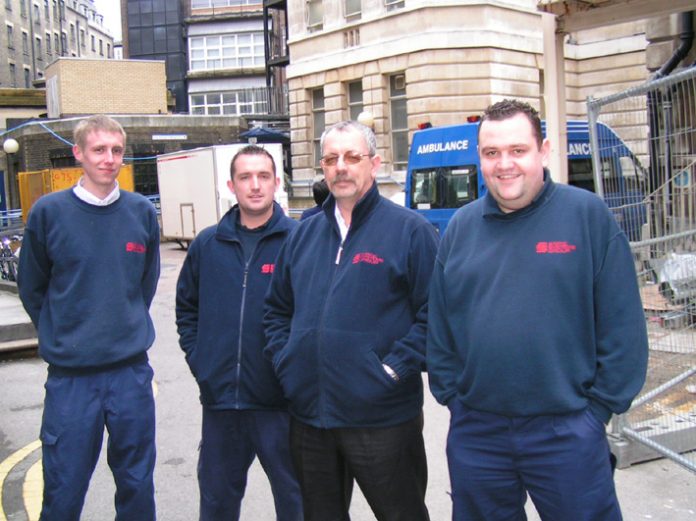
157,143,288,245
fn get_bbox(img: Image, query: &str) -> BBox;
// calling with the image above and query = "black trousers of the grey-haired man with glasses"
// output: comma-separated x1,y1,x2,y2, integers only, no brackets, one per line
290,414,429,521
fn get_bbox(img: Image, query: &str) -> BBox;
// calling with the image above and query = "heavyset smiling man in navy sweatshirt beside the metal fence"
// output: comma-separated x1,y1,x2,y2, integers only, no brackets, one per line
427,100,648,521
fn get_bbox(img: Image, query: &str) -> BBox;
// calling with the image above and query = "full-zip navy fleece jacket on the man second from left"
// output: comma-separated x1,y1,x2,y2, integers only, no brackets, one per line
176,203,297,410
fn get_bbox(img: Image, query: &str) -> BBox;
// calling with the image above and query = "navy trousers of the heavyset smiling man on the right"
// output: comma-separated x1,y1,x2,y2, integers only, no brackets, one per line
447,399,621,521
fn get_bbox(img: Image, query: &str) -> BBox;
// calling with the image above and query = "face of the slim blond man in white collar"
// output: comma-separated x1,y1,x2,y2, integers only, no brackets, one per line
73,130,125,198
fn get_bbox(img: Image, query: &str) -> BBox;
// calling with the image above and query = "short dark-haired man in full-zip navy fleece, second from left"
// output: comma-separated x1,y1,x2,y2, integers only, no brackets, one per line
176,145,303,521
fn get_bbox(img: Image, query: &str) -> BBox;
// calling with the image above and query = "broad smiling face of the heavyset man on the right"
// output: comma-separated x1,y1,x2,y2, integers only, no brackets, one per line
479,113,550,213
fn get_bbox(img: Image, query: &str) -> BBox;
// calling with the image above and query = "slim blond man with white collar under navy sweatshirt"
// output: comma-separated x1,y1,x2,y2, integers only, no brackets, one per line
17,116,159,521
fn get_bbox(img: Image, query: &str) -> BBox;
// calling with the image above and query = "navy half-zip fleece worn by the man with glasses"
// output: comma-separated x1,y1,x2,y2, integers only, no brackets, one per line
265,185,437,428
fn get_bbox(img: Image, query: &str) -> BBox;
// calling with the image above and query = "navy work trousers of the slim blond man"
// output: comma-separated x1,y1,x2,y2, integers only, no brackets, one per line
40,357,155,521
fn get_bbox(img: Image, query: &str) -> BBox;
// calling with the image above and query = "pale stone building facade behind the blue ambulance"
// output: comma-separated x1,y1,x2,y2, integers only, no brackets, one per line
287,0,648,195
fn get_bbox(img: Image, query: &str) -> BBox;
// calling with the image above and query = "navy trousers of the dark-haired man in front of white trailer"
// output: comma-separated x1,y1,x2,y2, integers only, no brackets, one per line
198,407,302,521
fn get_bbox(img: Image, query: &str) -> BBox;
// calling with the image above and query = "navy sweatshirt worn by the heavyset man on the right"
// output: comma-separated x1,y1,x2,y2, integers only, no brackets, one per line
427,174,648,422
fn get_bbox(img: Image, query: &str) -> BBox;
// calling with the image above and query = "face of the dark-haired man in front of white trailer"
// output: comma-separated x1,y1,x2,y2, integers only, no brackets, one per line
227,149,280,224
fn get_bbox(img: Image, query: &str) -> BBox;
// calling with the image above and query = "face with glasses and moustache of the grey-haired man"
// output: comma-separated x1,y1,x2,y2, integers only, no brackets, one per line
322,127,381,208
